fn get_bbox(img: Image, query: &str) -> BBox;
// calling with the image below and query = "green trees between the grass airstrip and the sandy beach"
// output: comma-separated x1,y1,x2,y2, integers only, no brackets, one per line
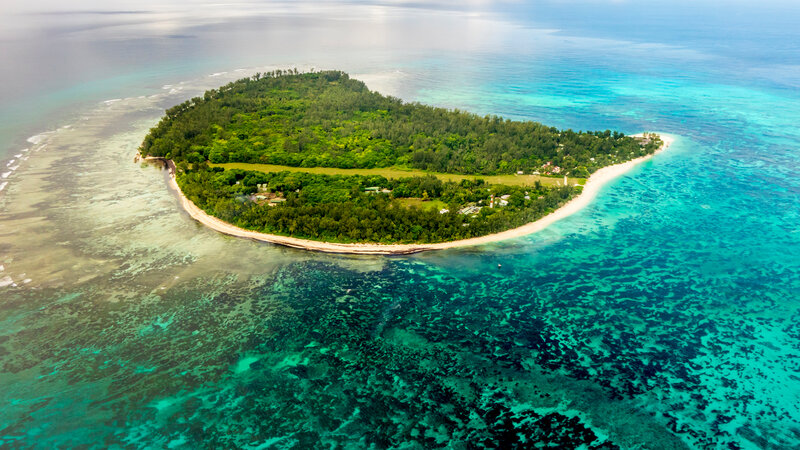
178,165,578,243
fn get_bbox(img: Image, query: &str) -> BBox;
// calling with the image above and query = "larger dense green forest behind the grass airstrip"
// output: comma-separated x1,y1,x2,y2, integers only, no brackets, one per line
142,71,660,177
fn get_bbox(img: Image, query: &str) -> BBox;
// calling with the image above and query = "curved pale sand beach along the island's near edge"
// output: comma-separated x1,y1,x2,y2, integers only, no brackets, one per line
147,133,675,255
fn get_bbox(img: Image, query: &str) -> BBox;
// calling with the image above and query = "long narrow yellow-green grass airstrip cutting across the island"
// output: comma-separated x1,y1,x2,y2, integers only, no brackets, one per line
209,163,586,186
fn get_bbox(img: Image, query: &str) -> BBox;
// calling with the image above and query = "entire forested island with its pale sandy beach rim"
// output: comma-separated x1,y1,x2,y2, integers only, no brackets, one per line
139,70,665,253
